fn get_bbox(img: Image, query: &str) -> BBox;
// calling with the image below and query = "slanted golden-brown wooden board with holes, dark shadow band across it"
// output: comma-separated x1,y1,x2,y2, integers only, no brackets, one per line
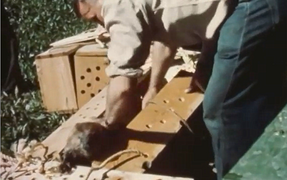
104,77,203,172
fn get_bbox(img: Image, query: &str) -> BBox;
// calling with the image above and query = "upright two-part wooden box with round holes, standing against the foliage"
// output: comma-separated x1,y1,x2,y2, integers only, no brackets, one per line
35,44,155,113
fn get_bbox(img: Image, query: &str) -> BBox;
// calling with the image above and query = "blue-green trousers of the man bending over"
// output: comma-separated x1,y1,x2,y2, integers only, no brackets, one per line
203,0,287,180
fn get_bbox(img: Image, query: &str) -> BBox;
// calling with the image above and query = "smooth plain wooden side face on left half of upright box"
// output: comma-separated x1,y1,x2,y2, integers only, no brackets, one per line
35,56,78,111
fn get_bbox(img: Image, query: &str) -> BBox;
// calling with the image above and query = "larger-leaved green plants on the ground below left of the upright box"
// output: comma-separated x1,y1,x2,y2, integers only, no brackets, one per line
1,89,68,155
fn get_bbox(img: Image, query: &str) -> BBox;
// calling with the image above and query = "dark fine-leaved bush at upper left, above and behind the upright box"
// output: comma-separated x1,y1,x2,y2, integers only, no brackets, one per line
4,0,92,82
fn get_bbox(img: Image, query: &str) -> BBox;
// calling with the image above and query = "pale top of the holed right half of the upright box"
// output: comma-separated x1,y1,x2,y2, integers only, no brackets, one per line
76,44,108,56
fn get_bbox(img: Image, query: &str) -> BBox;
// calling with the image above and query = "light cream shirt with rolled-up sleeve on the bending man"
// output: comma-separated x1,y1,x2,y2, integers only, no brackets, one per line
102,0,231,77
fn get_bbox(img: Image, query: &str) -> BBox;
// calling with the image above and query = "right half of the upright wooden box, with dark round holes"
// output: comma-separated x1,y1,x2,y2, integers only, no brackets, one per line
74,44,109,108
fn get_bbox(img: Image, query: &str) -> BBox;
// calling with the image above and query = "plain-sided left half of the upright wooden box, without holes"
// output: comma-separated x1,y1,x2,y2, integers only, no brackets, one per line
35,44,81,112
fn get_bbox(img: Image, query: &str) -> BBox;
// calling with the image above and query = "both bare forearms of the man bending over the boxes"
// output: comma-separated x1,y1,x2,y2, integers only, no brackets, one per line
105,42,176,128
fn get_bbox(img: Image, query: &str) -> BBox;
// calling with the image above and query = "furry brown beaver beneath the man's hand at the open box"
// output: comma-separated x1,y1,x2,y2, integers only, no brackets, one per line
60,121,115,173
